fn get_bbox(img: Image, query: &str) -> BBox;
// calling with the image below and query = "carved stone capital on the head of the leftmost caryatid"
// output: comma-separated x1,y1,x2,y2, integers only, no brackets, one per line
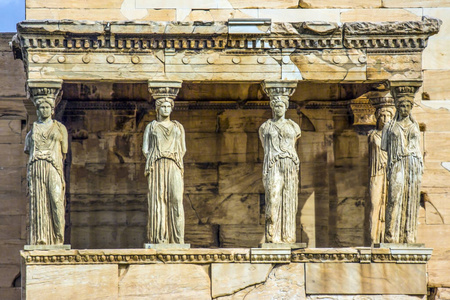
27,79,63,107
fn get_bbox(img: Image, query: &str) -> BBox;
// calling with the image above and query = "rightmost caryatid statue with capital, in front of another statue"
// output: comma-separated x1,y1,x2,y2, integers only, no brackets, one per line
381,81,423,243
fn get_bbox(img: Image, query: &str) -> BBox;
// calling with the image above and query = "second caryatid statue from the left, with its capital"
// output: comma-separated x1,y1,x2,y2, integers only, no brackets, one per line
142,81,186,244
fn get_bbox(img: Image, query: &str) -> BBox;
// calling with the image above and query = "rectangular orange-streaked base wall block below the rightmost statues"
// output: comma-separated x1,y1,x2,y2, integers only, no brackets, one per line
306,263,427,295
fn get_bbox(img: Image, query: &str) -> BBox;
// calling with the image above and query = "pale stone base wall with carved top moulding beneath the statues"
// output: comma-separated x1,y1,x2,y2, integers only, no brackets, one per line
21,248,431,300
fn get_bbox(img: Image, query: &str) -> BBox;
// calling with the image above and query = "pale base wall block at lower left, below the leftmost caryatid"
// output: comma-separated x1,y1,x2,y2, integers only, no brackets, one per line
22,264,118,300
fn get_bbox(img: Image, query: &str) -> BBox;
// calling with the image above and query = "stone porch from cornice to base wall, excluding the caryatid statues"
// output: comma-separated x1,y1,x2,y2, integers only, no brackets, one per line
13,18,440,299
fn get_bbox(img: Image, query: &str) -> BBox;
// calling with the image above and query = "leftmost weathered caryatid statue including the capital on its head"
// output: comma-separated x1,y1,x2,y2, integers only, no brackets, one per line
24,80,68,245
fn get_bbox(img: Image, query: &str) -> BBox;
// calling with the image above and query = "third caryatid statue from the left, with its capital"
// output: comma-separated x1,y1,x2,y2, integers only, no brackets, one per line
259,81,301,244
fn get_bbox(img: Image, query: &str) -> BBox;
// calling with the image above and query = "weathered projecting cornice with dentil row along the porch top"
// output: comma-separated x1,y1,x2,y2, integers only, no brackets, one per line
11,17,442,54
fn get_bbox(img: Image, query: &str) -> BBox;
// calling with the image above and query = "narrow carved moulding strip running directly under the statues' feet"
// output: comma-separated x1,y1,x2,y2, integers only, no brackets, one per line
21,247,432,265
